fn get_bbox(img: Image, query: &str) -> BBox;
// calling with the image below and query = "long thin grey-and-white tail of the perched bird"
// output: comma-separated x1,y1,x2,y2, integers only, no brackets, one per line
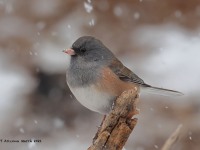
141,86,183,96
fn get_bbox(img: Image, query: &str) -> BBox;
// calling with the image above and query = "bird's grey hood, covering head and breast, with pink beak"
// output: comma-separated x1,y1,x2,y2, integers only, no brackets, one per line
64,36,115,87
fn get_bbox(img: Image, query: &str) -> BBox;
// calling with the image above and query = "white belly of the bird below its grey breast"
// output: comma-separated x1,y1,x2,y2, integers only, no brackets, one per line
69,85,114,114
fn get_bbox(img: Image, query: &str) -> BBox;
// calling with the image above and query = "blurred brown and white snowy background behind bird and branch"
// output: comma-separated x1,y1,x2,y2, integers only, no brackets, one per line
0,0,200,150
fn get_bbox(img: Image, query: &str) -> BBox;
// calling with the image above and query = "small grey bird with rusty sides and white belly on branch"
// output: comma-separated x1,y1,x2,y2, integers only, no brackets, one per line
64,36,182,114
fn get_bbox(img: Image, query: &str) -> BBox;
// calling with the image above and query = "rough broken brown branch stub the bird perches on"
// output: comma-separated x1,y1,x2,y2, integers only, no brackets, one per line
88,88,139,150
